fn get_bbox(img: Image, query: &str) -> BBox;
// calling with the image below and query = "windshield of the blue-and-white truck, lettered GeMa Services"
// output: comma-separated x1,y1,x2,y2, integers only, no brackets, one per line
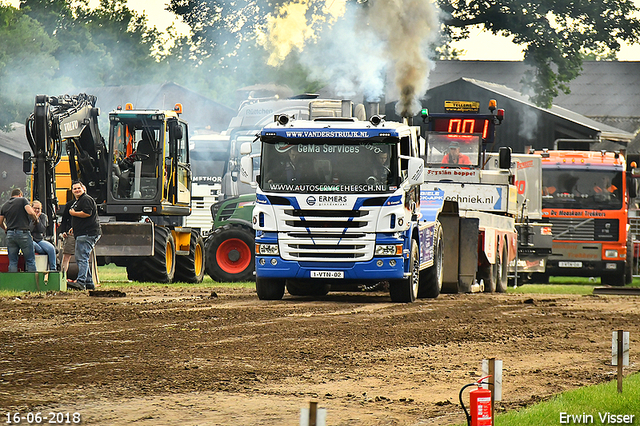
261,139,398,193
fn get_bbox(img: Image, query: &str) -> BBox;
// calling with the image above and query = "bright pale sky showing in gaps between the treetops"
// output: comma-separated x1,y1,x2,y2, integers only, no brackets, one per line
3,0,640,61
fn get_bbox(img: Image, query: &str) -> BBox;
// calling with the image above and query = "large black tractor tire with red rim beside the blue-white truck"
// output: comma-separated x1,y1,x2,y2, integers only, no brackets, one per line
205,224,255,282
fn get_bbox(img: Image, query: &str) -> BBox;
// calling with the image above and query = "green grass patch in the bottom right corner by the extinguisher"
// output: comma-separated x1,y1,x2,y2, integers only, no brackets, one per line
450,374,640,426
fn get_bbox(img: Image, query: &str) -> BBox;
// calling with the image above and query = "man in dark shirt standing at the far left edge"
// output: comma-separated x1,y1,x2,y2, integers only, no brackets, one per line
0,189,38,272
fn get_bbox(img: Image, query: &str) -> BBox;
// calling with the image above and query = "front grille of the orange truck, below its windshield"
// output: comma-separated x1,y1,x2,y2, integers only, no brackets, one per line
549,218,620,241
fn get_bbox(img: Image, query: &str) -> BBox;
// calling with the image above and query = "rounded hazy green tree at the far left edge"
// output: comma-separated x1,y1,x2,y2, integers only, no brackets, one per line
0,4,58,131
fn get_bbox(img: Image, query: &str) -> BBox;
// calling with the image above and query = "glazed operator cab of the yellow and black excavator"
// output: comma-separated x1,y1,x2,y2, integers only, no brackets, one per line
105,104,191,218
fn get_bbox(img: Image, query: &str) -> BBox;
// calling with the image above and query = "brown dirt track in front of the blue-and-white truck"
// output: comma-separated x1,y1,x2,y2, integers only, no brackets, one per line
0,287,640,426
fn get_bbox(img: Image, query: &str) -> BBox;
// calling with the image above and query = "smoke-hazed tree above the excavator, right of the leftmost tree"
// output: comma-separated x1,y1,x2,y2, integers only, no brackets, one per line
20,0,166,89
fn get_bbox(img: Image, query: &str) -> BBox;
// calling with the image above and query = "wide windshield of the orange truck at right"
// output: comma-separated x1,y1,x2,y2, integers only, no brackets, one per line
542,168,623,210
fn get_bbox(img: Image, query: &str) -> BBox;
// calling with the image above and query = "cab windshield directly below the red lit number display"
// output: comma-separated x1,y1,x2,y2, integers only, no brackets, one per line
424,133,482,167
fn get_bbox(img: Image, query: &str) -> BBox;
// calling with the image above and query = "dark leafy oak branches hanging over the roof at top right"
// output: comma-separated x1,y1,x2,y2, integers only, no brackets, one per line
437,0,640,107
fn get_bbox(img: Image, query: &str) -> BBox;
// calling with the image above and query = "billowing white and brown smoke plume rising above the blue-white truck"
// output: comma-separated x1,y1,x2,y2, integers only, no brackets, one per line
266,0,439,116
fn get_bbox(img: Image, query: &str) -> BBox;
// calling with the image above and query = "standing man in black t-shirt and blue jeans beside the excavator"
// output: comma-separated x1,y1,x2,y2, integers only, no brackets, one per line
68,181,101,290
